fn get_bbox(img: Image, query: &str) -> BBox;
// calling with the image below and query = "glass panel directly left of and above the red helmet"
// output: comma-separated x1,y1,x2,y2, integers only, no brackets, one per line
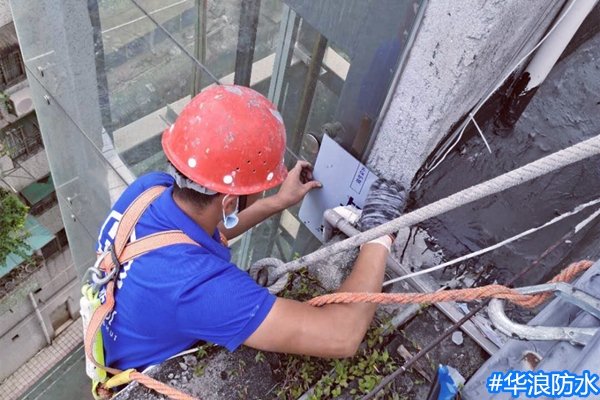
98,0,230,176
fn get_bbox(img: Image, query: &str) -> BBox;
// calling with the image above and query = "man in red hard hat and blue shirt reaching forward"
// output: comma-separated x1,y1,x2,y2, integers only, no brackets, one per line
97,85,406,371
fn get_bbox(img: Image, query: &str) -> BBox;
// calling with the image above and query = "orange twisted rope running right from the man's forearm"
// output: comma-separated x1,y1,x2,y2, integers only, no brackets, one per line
308,260,594,308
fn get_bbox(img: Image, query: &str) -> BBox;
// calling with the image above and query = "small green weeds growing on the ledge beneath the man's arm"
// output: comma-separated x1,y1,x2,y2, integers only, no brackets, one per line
188,269,435,400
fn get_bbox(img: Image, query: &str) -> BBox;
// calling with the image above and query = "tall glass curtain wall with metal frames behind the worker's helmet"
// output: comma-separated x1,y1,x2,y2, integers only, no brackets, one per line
12,0,420,272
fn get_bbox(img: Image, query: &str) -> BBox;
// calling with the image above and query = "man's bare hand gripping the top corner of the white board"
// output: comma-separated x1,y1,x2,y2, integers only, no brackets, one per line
274,161,323,210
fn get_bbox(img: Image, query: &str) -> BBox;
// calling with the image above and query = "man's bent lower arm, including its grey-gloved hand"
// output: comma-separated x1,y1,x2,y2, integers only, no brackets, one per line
244,180,406,358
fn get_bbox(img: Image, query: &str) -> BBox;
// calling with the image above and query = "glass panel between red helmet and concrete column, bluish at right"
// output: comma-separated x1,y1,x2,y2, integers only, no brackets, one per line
233,1,418,269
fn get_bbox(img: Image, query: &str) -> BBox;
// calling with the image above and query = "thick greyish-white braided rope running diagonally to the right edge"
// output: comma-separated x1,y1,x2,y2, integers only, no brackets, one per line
255,136,600,285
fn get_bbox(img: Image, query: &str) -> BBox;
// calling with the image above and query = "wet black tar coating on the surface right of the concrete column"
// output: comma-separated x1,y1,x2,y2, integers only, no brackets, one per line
413,30,600,286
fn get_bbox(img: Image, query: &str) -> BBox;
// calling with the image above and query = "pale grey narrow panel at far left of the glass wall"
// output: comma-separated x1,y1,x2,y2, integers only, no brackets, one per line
12,0,130,275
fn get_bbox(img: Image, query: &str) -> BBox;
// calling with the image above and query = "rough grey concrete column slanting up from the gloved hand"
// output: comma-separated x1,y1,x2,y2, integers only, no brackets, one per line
368,0,564,185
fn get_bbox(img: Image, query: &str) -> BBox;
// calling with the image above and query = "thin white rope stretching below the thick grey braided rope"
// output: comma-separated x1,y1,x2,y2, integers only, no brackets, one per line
383,199,600,286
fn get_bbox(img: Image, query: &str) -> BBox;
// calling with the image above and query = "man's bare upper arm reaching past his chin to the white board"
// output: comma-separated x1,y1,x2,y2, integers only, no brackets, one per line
218,161,321,239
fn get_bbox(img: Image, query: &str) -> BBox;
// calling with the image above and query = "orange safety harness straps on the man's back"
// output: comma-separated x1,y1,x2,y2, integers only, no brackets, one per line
80,186,227,400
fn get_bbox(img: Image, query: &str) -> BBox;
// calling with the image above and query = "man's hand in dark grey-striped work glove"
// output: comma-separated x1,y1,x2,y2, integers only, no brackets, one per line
360,179,408,232
